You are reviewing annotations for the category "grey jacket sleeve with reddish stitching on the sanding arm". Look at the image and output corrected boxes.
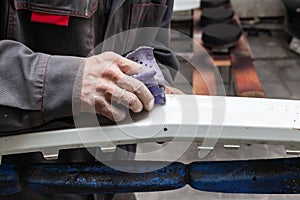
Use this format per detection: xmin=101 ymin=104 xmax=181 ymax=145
xmin=0 ymin=40 xmax=84 ymax=134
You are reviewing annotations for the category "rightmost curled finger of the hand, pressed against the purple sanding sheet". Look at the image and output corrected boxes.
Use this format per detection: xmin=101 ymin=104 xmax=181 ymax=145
xmin=117 ymin=76 xmax=154 ymax=111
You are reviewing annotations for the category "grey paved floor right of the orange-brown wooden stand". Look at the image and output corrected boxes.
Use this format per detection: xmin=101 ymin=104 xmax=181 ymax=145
xmin=248 ymin=32 xmax=300 ymax=99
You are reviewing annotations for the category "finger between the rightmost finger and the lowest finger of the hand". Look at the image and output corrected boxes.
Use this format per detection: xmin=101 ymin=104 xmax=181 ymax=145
xmin=112 ymin=86 xmax=143 ymax=113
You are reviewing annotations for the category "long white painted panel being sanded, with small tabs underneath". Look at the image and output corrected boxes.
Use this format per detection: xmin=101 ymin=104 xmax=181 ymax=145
xmin=0 ymin=95 xmax=300 ymax=162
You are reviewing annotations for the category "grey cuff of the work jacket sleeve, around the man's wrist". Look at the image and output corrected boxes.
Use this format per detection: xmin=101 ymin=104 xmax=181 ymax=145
xmin=41 ymin=56 xmax=85 ymax=123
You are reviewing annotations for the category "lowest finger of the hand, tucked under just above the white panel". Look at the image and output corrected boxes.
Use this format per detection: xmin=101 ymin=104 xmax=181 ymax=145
xmin=95 ymin=96 xmax=126 ymax=122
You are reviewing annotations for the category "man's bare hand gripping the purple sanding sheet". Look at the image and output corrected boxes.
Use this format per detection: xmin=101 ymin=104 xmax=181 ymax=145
xmin=81 ymin=52 xmax=154 ymax=121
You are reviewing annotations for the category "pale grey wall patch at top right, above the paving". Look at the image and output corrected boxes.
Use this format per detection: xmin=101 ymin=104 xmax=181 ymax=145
xmin=231 ymin=0 xmax=284 ymax=18
